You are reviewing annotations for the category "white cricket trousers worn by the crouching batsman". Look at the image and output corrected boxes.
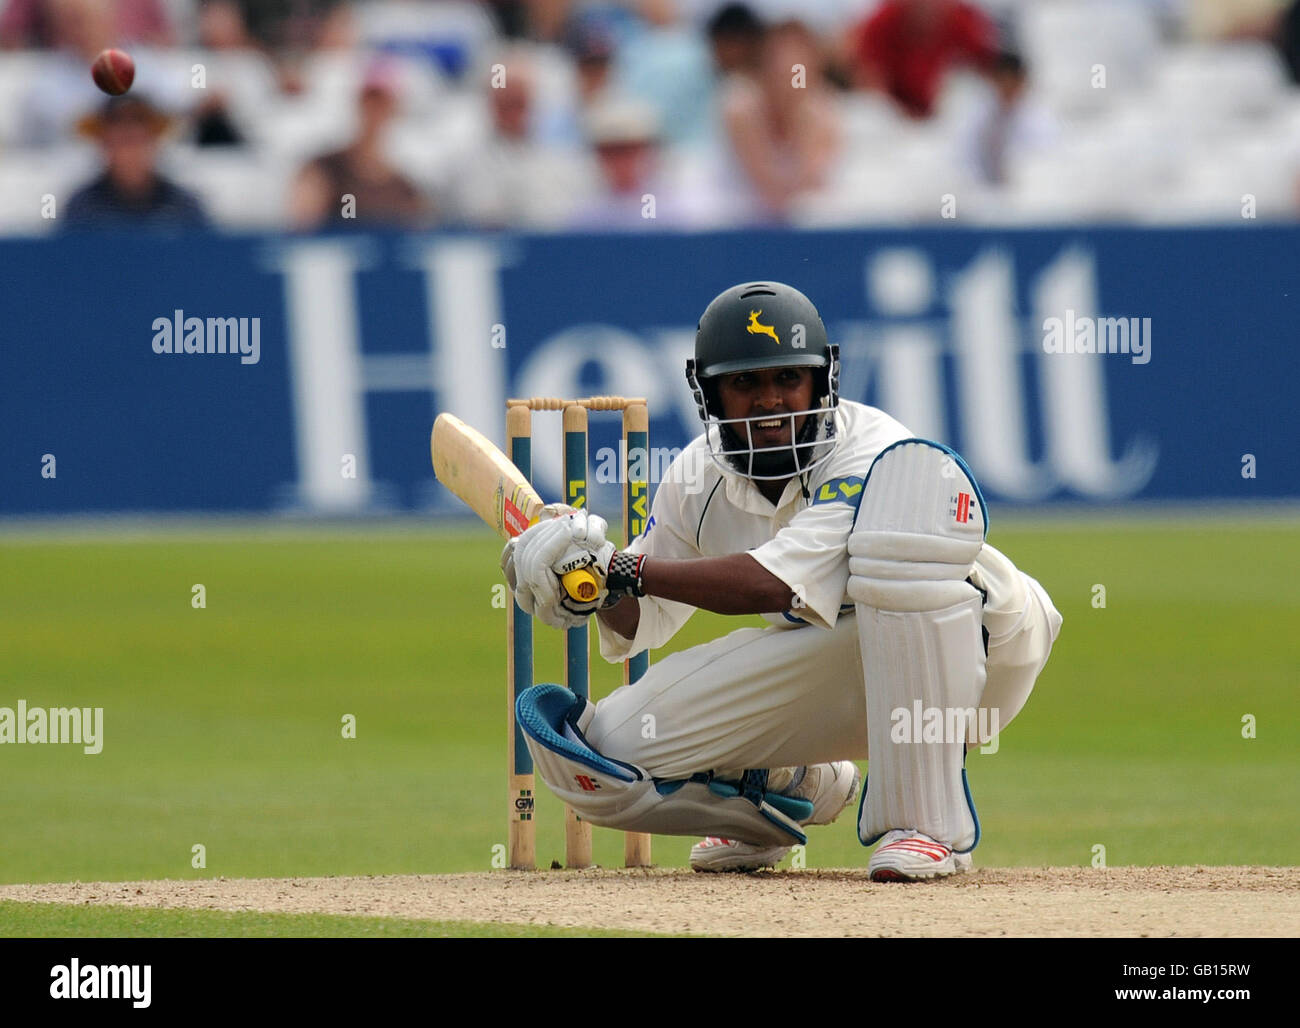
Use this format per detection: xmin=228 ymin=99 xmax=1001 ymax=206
xmin=586 ymin=546 xmax=1061 ymax=778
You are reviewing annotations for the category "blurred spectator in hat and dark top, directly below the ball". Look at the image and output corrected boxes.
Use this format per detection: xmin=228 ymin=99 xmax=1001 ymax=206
xmin=62 ymin=94 xmax=208 ymax=229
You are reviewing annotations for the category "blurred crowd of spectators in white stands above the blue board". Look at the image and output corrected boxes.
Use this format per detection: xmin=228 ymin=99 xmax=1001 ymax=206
xmin=0 ymin=0 xmax=1300 ymax=233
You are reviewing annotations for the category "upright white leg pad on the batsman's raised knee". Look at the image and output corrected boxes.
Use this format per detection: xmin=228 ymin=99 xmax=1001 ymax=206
xmin=848 ymin=439 xmax=985 ymax=851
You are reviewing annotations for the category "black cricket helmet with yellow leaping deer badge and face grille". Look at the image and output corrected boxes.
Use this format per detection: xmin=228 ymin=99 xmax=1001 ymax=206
xmin=686 ymin=282 xmax=840 ymax=481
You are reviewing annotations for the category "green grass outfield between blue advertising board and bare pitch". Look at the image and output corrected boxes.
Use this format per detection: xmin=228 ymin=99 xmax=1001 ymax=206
xmin=0 ymin=519 xmax=1300 ymax=899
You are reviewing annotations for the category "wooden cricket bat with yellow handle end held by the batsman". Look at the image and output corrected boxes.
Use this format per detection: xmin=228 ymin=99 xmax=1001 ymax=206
xmin=429 ymin=413 xmax=601 ymax=603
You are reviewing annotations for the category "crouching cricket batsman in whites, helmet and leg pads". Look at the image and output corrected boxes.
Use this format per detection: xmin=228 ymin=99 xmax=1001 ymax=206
xmin=502 ymin=282 xmax=1061 ymax=881
